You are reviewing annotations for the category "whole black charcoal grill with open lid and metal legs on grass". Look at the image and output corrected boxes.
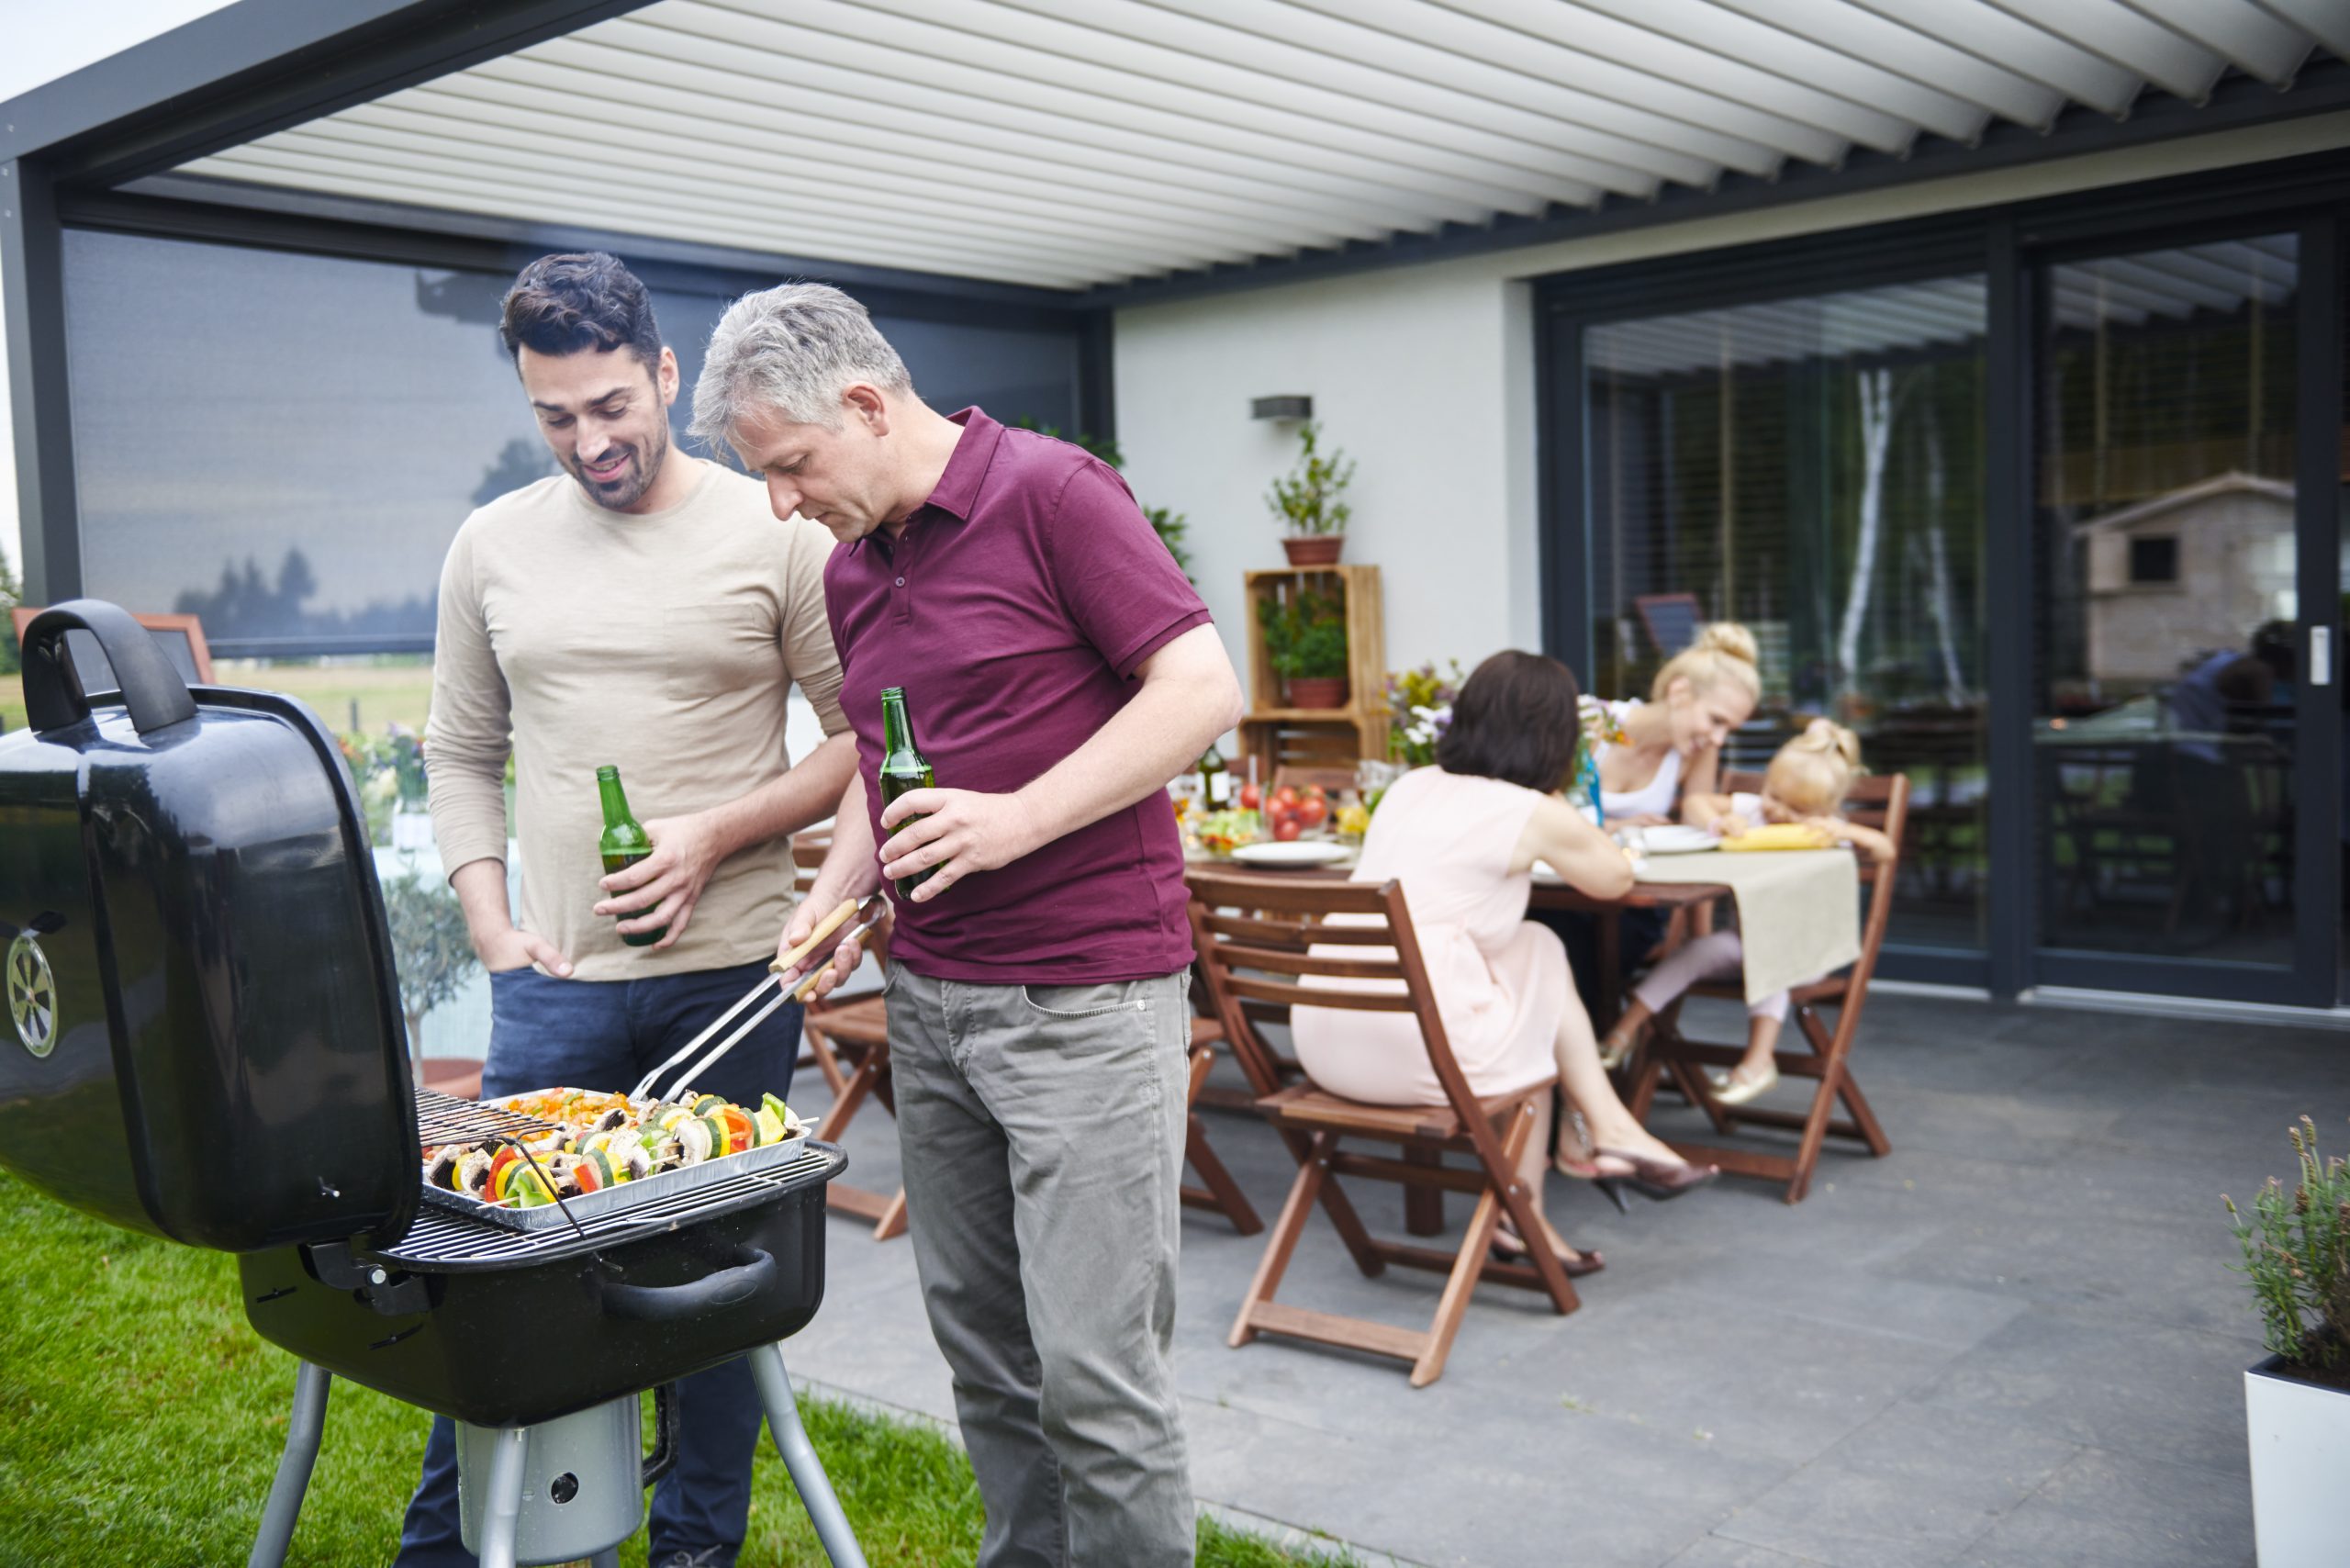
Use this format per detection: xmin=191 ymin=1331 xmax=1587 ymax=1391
xmin=0 ymin=599 xmax=863 ymax=1568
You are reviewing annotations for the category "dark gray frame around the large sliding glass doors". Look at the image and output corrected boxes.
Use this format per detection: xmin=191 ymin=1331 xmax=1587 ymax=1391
xmin=1535 ymin=152 xmax=2350 ymax=1006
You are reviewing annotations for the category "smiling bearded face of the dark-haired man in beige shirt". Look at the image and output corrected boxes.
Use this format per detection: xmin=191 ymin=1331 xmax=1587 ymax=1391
xmin=517 ymin=345 xmax=677 ymax=512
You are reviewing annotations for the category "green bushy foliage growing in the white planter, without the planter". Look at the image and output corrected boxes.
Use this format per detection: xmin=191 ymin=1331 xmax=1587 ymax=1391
xmin=2221 ymin=1116 xmax=2350 ymax=1378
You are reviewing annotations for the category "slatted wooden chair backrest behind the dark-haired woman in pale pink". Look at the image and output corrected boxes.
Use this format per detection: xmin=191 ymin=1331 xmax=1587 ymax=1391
xmin=1187 ymin=869 xmax=1499 ymax=1159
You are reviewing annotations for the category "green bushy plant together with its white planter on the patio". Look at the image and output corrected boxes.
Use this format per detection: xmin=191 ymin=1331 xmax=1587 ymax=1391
xmin=2221 ymin=1116 xmax=2350 ymax=1568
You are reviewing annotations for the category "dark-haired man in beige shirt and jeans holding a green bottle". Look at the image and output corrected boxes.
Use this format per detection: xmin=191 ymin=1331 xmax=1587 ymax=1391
xmin=399 ymin=254 xmax=856 ymax=1568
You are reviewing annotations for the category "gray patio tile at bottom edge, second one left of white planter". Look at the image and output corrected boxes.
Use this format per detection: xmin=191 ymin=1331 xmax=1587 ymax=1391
xmin=1716 ymin=1404 xmax=2080 ymax=1568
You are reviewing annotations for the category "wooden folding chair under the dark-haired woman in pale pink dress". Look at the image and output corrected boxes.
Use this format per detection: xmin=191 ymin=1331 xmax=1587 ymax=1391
xmin=1192 ymin=872 xmax=1579 ymax=1387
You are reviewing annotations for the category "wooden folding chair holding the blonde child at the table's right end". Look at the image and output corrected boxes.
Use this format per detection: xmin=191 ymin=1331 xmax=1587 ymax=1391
xmin=1628 ymin=773 xmax=1910 ymax=1204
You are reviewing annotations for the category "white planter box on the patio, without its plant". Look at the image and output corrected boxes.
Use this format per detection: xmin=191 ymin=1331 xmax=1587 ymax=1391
xmin=2244 ymin=1357 xmax=2350 ymax=1568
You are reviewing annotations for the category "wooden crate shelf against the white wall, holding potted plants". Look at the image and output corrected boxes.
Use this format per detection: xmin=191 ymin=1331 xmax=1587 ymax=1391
xmin=1241 ymin=566 xmax=1389 ymax=778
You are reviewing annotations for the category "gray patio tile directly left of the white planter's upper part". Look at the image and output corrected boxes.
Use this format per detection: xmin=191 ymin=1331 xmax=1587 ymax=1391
xmin=1915 ymin=1307 xmax=2258 ymax=1485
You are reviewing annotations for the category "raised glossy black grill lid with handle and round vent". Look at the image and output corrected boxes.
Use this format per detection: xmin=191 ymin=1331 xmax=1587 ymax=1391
xmin=0 ymin=599 xmax=420 ymax=1250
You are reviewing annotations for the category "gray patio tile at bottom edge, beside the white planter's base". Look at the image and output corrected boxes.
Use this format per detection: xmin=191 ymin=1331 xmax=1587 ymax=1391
xmin=1951 ymin=1448 xmax=2254 ymax=1568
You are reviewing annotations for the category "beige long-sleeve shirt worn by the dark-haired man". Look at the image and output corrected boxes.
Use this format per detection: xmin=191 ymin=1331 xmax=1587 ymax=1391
xmin=425 ymin=456 xmax=846 ymax=980
